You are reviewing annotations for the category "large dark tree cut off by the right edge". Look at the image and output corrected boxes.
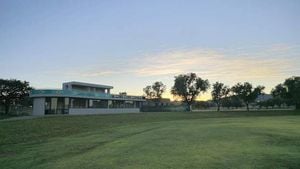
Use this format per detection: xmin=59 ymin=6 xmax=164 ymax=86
xmin=272 ymin=77 xmax=300 ymax=109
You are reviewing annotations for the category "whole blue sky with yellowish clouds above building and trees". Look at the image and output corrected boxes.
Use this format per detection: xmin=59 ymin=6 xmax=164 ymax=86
xmin=0 ymin=0 xmax=300 ymax=100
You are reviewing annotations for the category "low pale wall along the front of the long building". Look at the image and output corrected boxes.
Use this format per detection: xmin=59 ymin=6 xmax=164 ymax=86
xmin=69 ymin=108 xmax=140 ymax=115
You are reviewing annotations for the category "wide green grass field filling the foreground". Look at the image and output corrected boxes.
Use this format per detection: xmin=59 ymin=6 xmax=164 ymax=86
xmin=0 ymin=111 xmax=300 ymax=169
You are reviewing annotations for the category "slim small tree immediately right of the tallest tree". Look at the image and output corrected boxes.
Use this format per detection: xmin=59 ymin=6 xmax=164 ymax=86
xmin=211 ymin=82 xmax=230 ymax=111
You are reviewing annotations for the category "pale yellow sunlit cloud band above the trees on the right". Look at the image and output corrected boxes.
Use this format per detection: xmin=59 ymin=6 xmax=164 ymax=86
xmin=134 ymin=49 xmax=295 ymax=83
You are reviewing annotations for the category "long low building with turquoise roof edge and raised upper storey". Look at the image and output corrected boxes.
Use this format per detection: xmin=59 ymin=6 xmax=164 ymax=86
xmin=30 ymin=81 xmax=145 ymax=115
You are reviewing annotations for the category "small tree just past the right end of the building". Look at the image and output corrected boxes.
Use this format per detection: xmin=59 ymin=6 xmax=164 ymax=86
xmin=143 ymin=82 xmax=166 ymax=99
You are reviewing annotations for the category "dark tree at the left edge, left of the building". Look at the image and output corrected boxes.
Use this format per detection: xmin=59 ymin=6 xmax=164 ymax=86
xmin=0 ymin=79 xmax=32 ymax=114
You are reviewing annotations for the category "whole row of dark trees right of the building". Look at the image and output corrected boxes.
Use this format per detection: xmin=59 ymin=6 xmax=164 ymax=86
xmin=144 ymin=73 xmax=300 ymax=111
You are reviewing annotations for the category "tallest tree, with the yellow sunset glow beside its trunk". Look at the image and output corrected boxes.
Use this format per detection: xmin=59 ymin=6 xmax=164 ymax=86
xmin=171 ymin=73 xmax=209 ymax=111
